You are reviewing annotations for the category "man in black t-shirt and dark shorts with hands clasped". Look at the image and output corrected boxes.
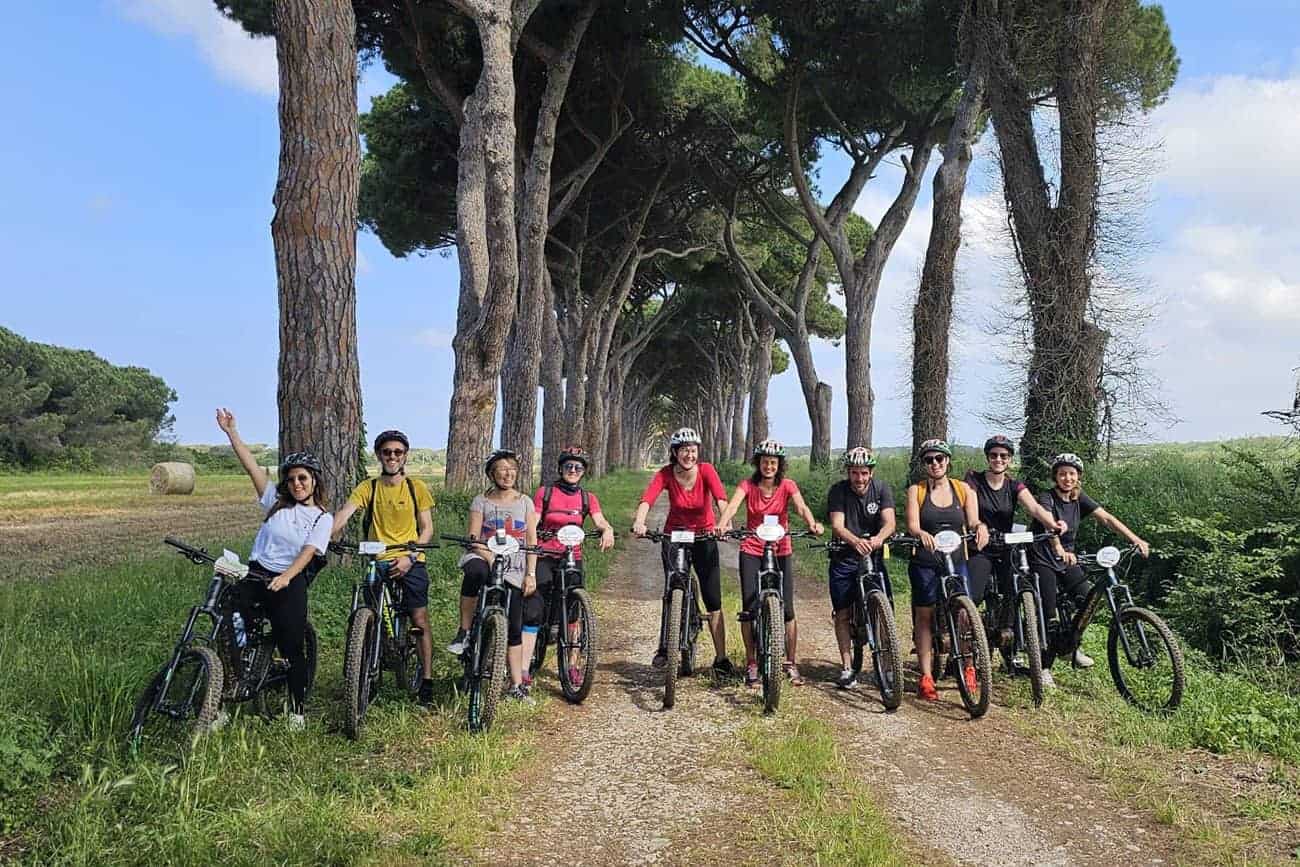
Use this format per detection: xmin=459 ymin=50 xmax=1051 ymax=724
xmin=826 ymin=446 xmax=894 ymax=689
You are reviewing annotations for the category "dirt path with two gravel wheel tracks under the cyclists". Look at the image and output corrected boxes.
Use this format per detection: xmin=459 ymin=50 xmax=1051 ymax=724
xmin=481 ymin=514 xmax=1201 ymax=866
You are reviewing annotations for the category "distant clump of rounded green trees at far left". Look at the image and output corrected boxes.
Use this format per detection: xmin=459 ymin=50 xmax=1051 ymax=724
xmin=0 ymin=328 xmax=176 ymax=469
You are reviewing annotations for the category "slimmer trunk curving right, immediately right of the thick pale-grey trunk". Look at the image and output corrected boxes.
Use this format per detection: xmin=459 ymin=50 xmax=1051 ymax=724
xmin=501 ymin=0 xmax=598 ymax=490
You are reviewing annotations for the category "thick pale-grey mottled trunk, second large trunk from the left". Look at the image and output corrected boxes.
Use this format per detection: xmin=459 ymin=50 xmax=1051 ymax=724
xmin=446 ymin=0 xmax=537 ymax=490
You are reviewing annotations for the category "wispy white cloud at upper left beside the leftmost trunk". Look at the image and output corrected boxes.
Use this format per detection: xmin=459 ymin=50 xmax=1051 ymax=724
xmin=118 ymin=0 xmax=280 ymax=96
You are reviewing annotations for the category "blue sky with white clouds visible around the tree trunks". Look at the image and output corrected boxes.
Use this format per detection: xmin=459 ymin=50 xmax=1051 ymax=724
xmin=0 ymin=6 xmax=1300 ymax=447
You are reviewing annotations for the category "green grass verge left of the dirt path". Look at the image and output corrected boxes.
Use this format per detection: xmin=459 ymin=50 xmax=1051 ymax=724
xmin=0 ymin=474 xmax=642 ymax=864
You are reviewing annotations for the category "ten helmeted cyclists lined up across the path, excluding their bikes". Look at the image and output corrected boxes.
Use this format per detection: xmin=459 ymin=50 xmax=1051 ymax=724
xmin=217 ymin=408 xmax=1149 ymax=728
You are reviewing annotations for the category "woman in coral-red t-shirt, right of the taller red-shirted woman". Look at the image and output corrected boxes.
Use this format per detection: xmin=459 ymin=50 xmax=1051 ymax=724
xmin=719 ymin=439 xmax=822 ymax=686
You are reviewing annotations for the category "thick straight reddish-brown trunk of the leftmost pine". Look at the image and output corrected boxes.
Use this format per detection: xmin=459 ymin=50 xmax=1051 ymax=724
xmin=270 ymin=0 xmax=361 ymax=507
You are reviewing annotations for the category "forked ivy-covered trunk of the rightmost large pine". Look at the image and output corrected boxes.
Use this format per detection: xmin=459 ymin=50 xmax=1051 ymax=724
xmin=972 ymin=0 xmax=1109 ymax=482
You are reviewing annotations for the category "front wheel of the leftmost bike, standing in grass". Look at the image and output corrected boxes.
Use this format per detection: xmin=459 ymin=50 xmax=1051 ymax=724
xmin=127 ymin=647 xmax=224 ymax=750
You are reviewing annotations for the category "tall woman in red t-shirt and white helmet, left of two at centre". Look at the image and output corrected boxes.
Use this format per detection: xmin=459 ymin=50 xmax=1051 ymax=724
xmin=632 ymin=428 xmax=735 ymax=675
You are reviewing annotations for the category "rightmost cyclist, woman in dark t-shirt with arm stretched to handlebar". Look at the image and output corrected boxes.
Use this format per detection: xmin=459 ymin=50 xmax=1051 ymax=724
xmin=1030 ymin=452 xmax=1151 ymax=686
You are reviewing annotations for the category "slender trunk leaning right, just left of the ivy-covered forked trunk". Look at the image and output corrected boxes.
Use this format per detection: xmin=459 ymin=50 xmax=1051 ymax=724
xmin=909 ymin=51 xmax=987 ymax=474
